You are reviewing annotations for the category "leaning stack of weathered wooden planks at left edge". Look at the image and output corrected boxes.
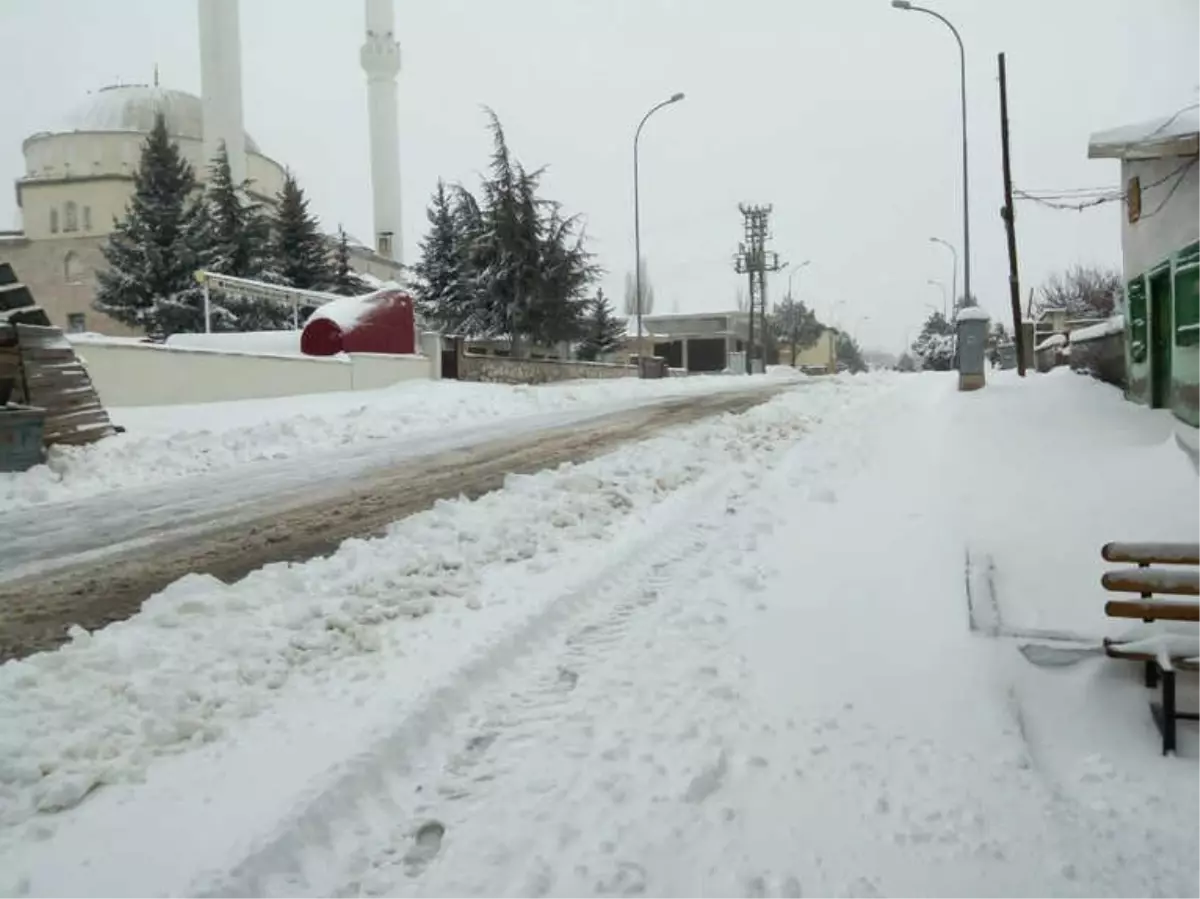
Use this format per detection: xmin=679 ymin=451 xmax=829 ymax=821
xmin=0 ymin=324 xmax=116 ymax=446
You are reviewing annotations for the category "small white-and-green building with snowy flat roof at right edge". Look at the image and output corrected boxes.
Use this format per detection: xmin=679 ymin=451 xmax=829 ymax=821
xmin=1088 ymin=110 xmax=1200 ymax=425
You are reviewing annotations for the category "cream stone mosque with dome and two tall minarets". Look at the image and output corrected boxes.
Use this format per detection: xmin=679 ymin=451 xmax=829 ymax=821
xmin=0 ymin=0 xmax=402 ymax=335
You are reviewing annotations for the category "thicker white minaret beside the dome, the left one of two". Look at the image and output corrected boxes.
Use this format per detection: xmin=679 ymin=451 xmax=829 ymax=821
xmin=199 ymin=0 xmax=246 ymax=184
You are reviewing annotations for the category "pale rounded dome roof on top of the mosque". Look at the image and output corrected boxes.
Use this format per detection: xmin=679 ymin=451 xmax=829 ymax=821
xmin=53 ymin=84 xmax=262 ymax=155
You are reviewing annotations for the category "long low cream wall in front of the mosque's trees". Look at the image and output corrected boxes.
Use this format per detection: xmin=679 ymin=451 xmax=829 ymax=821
xmin=76 ymin=341 xmax=437 ymax=407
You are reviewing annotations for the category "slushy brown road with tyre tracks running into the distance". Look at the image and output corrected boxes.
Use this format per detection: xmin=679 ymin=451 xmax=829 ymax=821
xmin=0 ymin=386 xmax=780 ymax=661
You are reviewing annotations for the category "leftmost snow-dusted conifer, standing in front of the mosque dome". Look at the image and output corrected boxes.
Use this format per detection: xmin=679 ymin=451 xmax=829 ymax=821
xmin=94 ymin=115 xmax=205 ymax=335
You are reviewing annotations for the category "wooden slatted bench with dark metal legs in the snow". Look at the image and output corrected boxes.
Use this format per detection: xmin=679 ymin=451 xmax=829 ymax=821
xmin=1100 ymin=543 xmax=1200 ymax=755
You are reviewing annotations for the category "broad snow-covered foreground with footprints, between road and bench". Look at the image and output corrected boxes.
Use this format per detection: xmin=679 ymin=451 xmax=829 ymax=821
xmin=0 ymin=373 xmax=1200 ymax=899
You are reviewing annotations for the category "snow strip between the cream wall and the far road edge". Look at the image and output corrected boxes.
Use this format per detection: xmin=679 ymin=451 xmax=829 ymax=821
xmin=0 ymin=373 xmax=800 ymax=509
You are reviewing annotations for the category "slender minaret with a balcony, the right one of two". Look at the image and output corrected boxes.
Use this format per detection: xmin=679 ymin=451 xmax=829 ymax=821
xmin=362 ymin=0 xmax=404 ymax=263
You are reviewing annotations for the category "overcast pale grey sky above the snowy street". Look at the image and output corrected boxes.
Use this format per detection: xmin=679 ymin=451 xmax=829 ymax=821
xmin=0 ymin=0 xmax=1200 ymax=349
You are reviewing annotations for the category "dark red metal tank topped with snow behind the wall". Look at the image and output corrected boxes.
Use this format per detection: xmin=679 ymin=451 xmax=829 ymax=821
xmin=300 ymin=289 xmax=416 ymax=355
